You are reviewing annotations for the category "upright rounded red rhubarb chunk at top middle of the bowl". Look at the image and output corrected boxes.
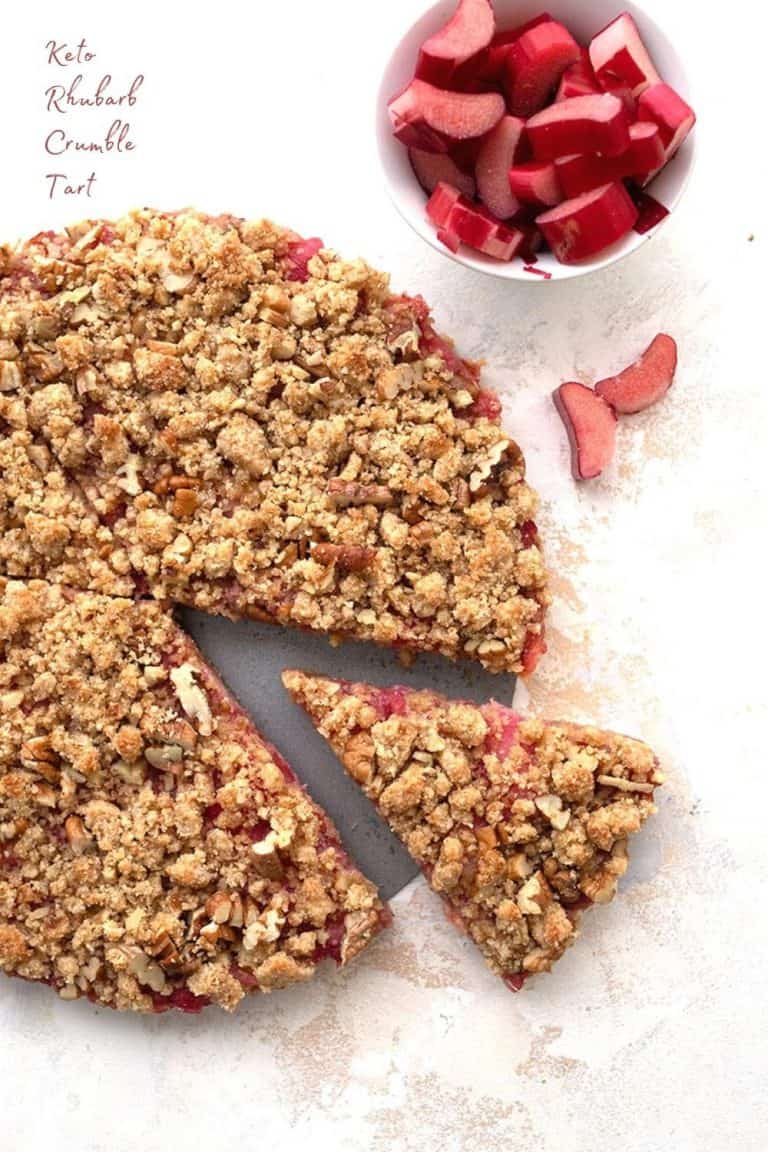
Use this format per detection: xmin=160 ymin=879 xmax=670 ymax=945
xmin=504 ymin=20 xmax=580 ymax=116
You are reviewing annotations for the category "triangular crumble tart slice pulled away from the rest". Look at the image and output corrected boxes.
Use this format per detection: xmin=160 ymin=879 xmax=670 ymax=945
xmin=283 ymin=672 xmax=663 ymax=990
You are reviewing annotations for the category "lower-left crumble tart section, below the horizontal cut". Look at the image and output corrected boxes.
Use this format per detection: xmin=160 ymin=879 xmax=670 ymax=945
xmin=0 ymin=579 xmax=388 ymax=1011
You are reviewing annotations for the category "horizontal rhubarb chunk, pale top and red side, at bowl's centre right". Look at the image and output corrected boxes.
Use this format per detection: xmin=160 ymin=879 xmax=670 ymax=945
xmin=525 ymin=92 xmax=630 ymax=160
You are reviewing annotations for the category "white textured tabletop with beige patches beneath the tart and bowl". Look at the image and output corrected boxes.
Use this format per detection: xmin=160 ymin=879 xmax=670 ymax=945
xmin=0 ymin=0 xmax=768 ymax=1152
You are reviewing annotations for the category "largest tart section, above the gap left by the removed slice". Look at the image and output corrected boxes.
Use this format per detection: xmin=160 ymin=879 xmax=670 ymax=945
xmin=0 ymin=211 xmax=547 ymax=673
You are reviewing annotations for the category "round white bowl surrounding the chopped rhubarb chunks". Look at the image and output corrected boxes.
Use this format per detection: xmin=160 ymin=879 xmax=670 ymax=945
xmin=377 ymin=0 xmax=695 ymax=283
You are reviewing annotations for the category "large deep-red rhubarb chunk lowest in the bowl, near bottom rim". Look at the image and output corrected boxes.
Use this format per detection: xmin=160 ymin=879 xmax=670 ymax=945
xmin=537 ymin=182 xmax=638 ymax=264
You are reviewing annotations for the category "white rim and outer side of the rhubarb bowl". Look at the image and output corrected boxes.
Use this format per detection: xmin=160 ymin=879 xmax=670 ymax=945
xmin=374 ymin=0 xmax=697 ymax=285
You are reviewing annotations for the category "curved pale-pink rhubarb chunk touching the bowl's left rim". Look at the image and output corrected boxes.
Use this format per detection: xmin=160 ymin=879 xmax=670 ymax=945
xmin=388 ymin=79 xmax=504 ymax=152
